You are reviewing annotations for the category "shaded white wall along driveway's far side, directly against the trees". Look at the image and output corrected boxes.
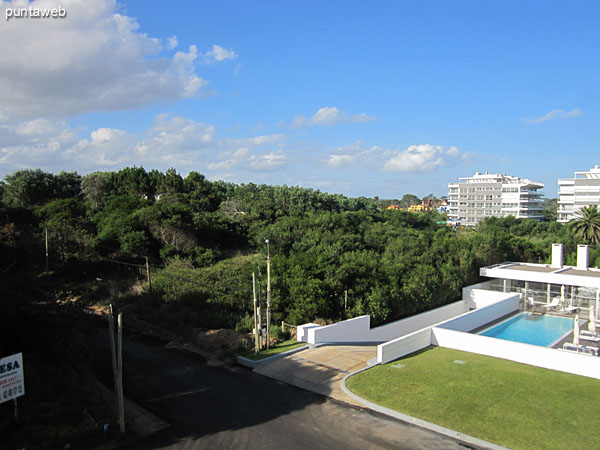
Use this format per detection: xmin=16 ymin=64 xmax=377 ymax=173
xmin=308 ymin=300 xmax=469 ymax=344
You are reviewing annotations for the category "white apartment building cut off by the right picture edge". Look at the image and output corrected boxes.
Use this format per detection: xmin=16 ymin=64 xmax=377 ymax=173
xmin=558 ymin=165 xmax=600 ymax=222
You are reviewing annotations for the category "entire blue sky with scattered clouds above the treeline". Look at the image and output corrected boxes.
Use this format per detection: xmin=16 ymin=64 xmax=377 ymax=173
xmin=0 ymin=0 xmax=600 ymax=198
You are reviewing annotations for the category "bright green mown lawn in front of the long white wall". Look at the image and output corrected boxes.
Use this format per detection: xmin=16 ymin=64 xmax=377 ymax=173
xmin=347 ymin=347 xmax=600 ymax=449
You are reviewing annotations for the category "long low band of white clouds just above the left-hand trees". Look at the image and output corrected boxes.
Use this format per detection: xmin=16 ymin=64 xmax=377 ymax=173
xmin=0 ymin=114 xmax=287 ymax=173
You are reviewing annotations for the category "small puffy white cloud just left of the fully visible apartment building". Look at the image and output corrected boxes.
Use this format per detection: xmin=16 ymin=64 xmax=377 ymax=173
xmin=382 ymin=144 xmax=465 ymax=172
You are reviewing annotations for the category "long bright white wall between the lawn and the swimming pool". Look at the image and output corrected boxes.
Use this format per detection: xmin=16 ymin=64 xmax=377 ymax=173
xmin=432 ymin=327 xmax=600 ymax=379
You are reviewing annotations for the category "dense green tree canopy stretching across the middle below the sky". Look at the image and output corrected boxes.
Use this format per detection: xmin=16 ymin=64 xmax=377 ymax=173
xmin=0 ymin=167 xmax=600 ymax=329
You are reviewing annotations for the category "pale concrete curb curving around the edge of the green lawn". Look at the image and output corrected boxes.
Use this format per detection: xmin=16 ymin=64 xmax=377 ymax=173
xmin=342 ymin=366 xmax=509 ymax=450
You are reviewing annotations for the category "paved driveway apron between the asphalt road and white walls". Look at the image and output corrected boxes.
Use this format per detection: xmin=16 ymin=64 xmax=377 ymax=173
xmin=254 ymin=345 xmax=377 ymax=406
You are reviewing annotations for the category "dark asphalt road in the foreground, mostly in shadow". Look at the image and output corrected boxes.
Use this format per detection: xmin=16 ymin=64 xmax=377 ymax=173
xmin=93 ymin=331 xmax=474 ymax=450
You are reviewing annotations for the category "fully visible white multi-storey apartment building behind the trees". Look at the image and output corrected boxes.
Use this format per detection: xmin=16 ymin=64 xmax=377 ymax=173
xmin=448 ymin=172 xmax=544 ymax=226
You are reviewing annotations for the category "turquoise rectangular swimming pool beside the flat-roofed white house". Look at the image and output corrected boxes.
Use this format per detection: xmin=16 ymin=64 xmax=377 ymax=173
xmin=479 ymin=313 xmax=573 ymax=347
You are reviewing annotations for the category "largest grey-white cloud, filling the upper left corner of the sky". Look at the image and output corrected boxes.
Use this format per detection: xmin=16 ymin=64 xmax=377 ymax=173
xmin=0 ymin=0 xmax=209 ymax=120
